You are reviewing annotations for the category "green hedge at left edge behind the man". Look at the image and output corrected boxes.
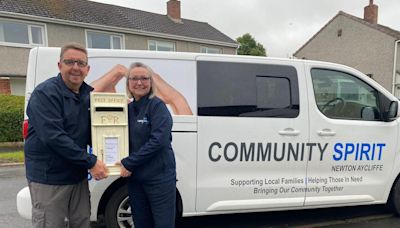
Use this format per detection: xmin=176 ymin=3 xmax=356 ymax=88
xmin=0 ymin=95 xmax=25 ymax=142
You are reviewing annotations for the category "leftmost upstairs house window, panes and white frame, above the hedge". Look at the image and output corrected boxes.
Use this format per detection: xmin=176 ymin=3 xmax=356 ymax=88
xmin=0 ymin=20 xmax=45 ymax=46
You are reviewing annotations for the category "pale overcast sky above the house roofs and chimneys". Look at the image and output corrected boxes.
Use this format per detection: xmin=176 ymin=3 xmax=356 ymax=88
xmin=90 ymin=0 xmax=400 ymax=57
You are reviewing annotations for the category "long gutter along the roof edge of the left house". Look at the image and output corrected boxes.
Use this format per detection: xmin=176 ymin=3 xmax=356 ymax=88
xmin=0 ymin=11 xmax=239 ymax=48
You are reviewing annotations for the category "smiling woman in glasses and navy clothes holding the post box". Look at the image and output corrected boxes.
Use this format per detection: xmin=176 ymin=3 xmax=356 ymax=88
xmin=121 ymin=63 xmax=176 ymax=228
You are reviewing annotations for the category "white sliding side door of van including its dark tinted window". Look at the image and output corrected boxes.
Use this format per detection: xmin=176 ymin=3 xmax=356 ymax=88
xmin=196 ymin=57 xmax=308 ymax=214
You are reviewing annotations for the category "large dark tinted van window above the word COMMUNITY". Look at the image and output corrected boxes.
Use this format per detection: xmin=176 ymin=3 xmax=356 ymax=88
xmin=197 ymin=61 xmax=299 ymax=118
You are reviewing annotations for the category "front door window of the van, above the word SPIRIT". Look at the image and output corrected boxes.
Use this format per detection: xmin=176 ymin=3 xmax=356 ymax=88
xmin=311 ymin=69 xmax=381 ymax=120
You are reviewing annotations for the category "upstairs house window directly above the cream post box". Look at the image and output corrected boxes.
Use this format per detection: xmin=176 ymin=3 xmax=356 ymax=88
xmin=86 ymin=31 xmax=123 ymax=49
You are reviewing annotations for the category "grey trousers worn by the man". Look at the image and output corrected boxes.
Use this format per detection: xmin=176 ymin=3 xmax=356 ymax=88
xmin=28 ymin=179 xmax=90 ymax=228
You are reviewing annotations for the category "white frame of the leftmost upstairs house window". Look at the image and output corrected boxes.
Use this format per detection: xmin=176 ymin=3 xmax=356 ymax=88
xmin=0 ymin=18 xmax=48 ymax=48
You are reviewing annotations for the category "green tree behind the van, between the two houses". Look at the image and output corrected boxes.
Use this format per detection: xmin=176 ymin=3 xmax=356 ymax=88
xmin=236 ymin=33 xmax=267 ymax=56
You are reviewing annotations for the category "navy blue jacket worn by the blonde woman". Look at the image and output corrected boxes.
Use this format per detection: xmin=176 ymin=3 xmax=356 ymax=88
xmin=121 ymin=96 xmax=176 ymax=183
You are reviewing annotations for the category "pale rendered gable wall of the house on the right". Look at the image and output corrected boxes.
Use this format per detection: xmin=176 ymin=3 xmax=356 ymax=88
xmin=294 ymin=11 xmax=400 ymax=94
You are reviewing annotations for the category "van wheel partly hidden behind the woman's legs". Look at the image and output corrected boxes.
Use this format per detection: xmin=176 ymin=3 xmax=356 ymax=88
xmin=105 ymin=185 xmax=134 ymax=228
